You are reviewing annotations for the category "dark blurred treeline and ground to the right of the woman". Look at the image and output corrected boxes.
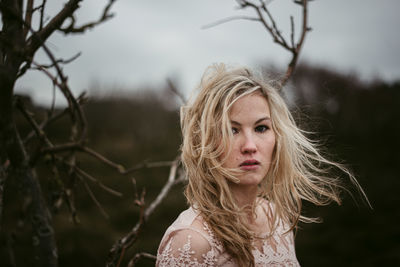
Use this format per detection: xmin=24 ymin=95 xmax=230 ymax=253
xmin=292 ymin=66 xmax=400 ymax=266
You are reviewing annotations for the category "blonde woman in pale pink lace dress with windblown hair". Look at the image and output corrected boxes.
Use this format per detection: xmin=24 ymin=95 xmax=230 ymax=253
xmin=157 ymin=64 xmax=366 ymax=266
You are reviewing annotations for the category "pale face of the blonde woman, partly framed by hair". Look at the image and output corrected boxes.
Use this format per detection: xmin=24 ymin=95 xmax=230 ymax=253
xmin=223 ymin=92 xmax=275 ymax=185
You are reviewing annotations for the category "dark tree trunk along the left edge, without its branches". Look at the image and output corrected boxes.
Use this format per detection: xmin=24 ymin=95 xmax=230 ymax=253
xmin=0 ymin=0 xmax=57 ymax=266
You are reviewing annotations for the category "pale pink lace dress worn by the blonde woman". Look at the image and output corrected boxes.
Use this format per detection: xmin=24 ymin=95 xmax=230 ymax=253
xmin=156 ymin=204 xmax=300 ymax=267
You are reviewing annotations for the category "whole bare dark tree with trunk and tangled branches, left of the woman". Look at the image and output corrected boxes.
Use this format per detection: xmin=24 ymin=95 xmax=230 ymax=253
xmin=0 ymin=0 xmax=155 ymax=266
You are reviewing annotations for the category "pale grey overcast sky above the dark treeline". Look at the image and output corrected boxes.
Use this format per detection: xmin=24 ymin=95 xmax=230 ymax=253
xmin=17 ymin=0 xmax=400 ymax=103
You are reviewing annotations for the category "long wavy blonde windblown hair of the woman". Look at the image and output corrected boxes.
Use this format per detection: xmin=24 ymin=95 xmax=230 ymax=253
xmin=181 ymin=64 xmax=368 ymax=266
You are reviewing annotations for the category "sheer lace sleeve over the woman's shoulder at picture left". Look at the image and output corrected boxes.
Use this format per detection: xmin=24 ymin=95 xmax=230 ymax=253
xmin=156 ymin=229 xmax=216 ymax=267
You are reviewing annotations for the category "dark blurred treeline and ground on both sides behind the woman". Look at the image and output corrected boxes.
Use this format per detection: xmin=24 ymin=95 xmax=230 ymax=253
xmin=0 ymin=65 xmax=400 ymax=266
